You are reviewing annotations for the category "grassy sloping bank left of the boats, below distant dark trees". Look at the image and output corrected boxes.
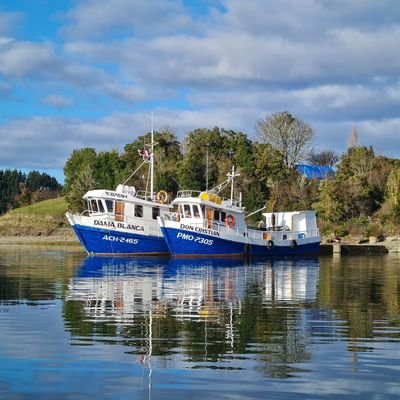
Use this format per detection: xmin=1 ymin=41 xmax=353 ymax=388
xmin=0 ymin=197 xmax=75 ymax=240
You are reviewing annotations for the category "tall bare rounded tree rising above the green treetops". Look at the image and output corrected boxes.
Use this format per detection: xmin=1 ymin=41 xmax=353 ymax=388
xmin=256 ymin=111 xmax=314 ymax=168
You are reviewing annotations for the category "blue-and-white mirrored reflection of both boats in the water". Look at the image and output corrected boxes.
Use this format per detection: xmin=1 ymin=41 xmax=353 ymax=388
xmin=67 ymin=257 xmax=319 ymax=321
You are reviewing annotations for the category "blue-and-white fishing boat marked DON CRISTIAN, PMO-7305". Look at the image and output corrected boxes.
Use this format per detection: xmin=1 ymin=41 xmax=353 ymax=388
xmin=158 ymin=167 xmax=320 ymax=257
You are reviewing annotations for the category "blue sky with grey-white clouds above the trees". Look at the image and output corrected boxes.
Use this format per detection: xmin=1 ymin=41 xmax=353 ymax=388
xmin=0 ymin=0 xmax=400 ymax=181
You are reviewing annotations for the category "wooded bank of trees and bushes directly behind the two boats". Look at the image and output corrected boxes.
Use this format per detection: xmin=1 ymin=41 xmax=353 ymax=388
xmin=64 ymin=112 xmax=400 ymax=236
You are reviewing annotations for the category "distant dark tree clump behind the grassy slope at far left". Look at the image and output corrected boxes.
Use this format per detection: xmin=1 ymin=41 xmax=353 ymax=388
xmin=0 ymin=169 xmax=62 ymax=215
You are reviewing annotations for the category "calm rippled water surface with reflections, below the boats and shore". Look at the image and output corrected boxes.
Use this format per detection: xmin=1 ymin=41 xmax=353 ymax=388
xmin=0 ymin=245 xmax=400 ymax=400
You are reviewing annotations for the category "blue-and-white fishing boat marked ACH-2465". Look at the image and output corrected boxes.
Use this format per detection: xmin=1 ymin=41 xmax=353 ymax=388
xmin=66 ymin=130 xmax=172 ymax=256
